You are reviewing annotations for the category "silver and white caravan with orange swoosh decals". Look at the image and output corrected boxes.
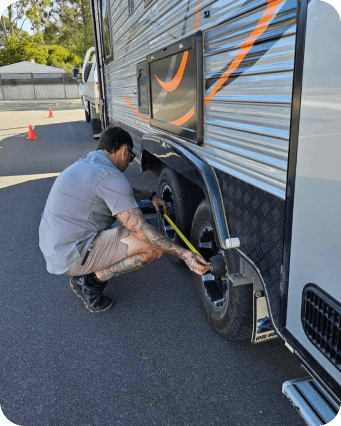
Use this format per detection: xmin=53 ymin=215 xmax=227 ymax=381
xmin=90 ymin=0 xmax=341 ymax=426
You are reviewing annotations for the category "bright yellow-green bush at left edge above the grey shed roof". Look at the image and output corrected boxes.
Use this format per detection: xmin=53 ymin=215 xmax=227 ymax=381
xmin=0 ymin=34 xmax=48 ymax=66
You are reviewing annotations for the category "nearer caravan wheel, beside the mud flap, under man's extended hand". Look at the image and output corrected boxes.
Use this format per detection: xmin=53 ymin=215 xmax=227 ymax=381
xmin=191 ymin=200 xmax=253 ymax=340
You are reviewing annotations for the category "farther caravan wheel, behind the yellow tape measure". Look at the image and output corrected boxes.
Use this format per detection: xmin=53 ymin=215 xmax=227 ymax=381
xmin=157 ymin=167 xmax=197 ymax=264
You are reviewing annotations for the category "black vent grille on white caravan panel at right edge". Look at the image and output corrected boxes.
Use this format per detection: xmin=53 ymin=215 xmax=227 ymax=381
xmin=302 ymin=285 xmax=341 ymax=371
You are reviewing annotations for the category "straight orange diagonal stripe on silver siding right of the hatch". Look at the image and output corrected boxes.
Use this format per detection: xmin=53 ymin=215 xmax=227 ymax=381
xmin=205 ymin=0 xmax=282 ymax=105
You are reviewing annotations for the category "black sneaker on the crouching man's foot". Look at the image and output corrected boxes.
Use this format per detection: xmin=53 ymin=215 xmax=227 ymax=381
xmin=70 ymin=275 xmax=114 ymax=313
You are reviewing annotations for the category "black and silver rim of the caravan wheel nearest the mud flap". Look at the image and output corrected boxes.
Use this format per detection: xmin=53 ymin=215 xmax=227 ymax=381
xmin=199 ymin=226 xmax=229 ymax=311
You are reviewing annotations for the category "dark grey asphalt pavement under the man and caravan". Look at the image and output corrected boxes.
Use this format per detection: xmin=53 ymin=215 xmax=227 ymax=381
xmin=0 ymin=107 xmax=306 ymax=426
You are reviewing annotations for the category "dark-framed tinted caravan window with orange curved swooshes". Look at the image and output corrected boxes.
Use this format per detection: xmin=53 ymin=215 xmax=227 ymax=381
xmin=147 ymin=32 xmax=204 ymax=143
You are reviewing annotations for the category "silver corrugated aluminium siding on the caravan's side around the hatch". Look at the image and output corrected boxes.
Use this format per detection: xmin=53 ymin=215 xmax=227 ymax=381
xmin=101 ymin=0 xmax=296 ymax=199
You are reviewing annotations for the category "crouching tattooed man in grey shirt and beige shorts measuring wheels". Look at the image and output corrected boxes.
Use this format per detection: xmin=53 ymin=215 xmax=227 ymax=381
xmin=39 ymin=127 xmax=211 ymax=313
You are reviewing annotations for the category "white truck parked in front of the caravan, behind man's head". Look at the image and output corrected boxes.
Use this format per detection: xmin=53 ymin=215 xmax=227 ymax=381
xmin=80 ymin=47 xmax=102 ymax=138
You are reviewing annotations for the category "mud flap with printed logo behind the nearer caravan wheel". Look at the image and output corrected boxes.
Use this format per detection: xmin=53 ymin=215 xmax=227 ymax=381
xmin=251 ymin=291 xmax=277 ymax=343
